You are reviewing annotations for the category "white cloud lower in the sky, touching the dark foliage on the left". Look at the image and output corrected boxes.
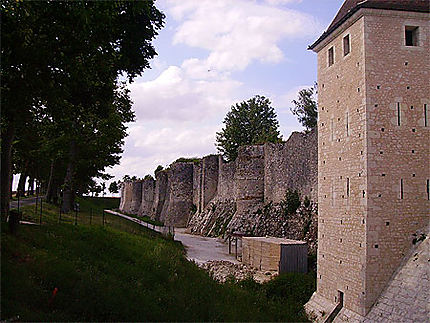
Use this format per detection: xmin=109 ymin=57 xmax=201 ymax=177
xmin=130 ymin=66 xmax=241 ymax=122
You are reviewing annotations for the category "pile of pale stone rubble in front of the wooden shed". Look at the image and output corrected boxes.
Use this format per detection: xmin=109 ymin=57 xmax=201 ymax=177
xmin=200 ymin=260 xmax=278 ymax=283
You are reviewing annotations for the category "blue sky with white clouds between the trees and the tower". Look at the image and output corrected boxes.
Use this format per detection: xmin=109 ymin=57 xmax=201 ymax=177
xmin=107 ymin=0 xmax=342 ymax=185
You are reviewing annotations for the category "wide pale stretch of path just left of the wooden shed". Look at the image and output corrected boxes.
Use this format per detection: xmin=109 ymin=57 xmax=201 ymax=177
xmin=175 ymin=229 xmax=239 ymax=264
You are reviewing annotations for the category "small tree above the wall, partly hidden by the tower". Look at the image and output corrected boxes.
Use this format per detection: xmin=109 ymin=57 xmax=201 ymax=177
xmin=291 ymin=84 xmax=318 ymax=130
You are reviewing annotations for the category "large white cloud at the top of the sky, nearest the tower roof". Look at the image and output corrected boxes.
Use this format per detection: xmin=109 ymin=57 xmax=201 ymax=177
xmin=168 ymin=0 xmax=321 ymax=72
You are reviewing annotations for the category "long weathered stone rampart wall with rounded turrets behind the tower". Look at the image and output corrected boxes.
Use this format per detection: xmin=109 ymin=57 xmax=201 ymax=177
xmin=121 ymin=131 xmax=317 ymax=233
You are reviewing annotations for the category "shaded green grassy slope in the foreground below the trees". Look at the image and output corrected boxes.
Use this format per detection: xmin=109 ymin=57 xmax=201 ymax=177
xmin=1 ymin=200 xmax=315 ymax=321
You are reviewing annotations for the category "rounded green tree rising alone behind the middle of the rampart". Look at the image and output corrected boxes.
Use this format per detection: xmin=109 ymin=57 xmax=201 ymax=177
xmin=216 ymin=95 xmax=282 ymax=161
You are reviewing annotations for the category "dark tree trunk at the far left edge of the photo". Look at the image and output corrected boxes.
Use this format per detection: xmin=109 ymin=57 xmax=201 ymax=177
xmin=0 ymin=124 xmax=15 ymax=219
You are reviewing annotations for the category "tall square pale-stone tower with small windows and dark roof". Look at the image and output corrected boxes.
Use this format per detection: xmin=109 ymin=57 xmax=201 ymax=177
xmin=306 ymin=0 xmax=430 ymax=317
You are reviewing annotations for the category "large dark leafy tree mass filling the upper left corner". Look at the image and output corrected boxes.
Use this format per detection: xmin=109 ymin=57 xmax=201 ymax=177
xmin=1 ymin=0 xmax=164 ymax=216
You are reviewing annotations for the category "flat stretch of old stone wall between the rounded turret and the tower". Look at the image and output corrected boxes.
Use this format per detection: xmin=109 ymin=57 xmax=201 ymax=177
xmin=264 ymin=130 xmax=318 ymax=204
